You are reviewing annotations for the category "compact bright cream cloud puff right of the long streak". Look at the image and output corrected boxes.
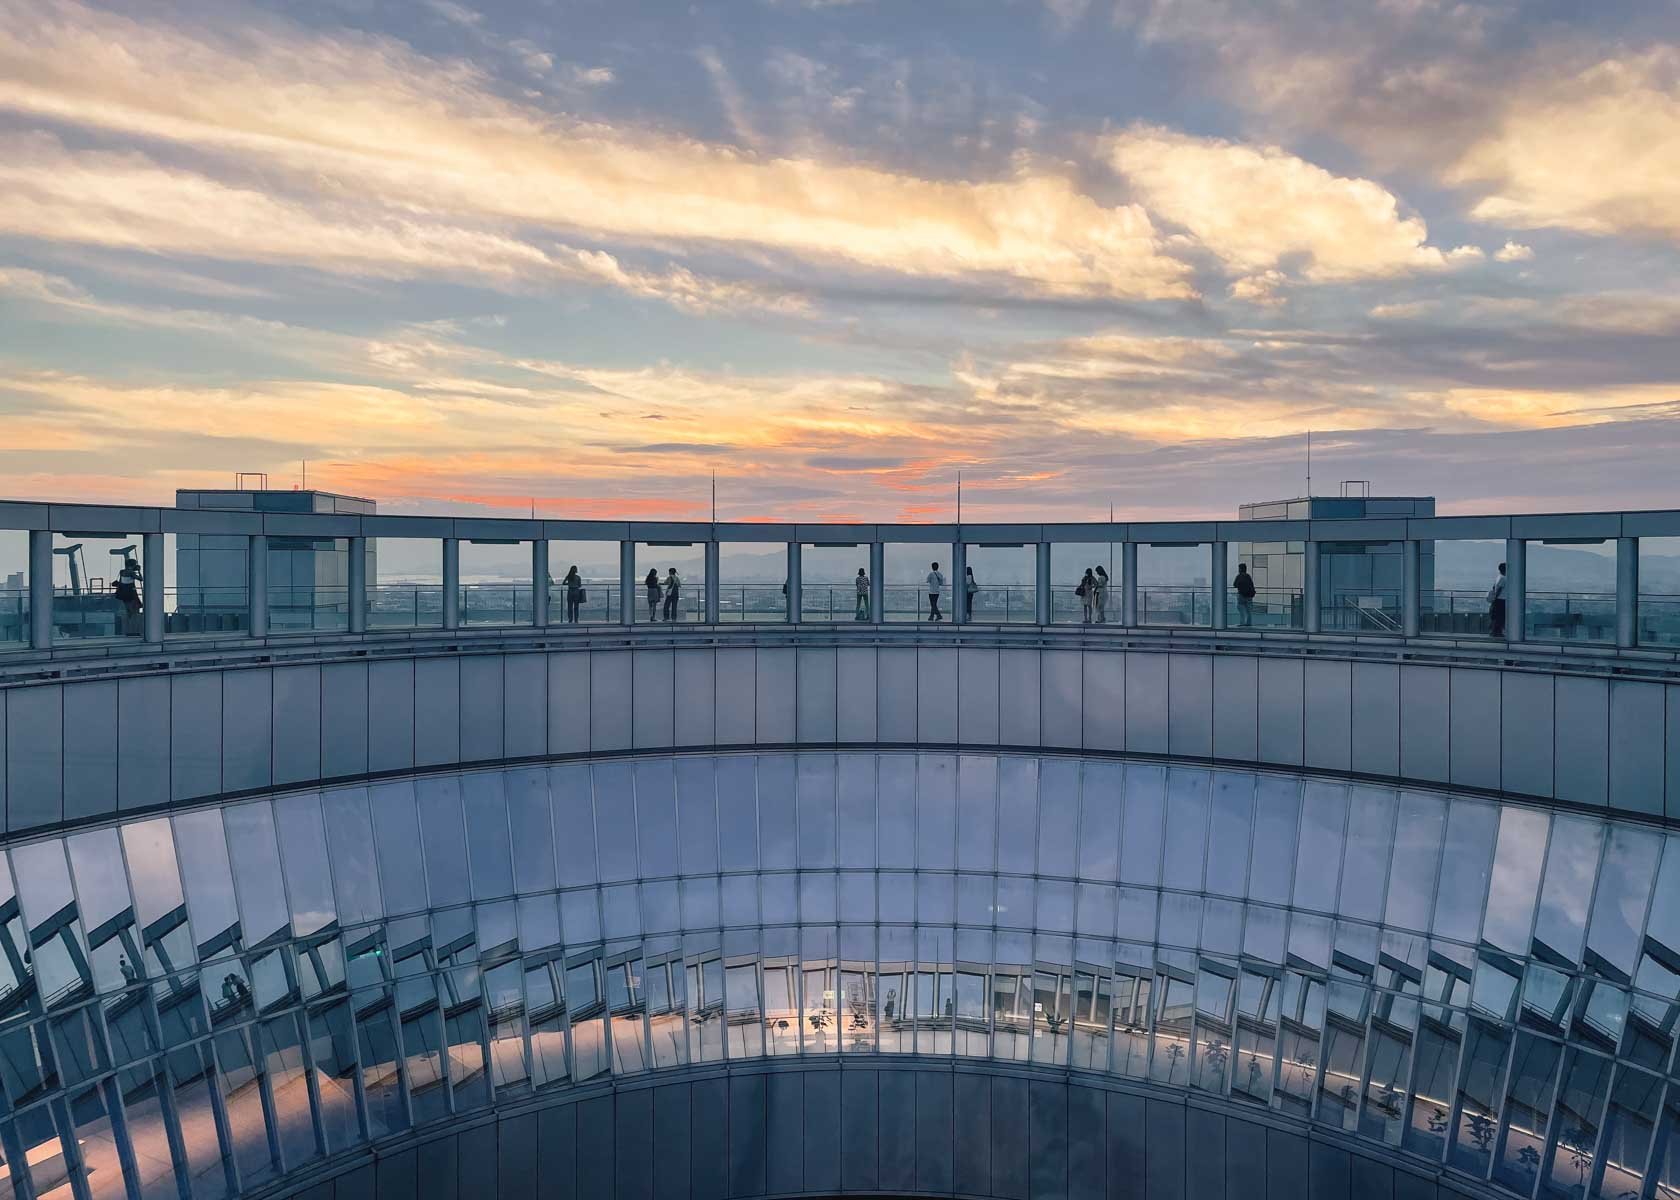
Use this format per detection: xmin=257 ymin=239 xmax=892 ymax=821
xmin=1105 ymin=126 xmax=1480 ymax=285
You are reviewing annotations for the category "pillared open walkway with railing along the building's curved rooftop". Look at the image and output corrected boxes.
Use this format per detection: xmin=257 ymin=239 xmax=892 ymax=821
xmin=0 ymin=503 xmax=1680 ymax=652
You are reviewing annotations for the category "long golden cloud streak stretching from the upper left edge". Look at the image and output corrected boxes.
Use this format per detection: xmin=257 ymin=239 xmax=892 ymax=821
xmin=0 ymin=0 xmax=1193 ymax=299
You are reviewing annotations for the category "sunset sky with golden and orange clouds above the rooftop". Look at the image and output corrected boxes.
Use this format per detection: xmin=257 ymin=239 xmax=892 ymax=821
xmin=0 ymin=0 xmax=1680 ymax=521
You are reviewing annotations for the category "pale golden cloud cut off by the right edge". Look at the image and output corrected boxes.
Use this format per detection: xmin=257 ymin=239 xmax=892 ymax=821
xmin=1446 ymin=47 xmax=1680 ymax=240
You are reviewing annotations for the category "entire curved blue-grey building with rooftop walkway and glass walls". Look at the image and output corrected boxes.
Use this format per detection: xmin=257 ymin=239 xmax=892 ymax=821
xmin=0 ymin=503 xmax=1680 ymax=1200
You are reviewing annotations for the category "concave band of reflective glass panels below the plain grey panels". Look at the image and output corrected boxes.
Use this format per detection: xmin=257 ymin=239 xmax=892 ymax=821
xmin=0 ymin=751 xmax=1680 ymax=1200
